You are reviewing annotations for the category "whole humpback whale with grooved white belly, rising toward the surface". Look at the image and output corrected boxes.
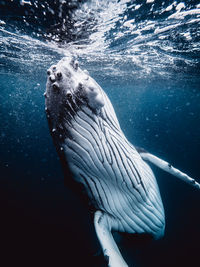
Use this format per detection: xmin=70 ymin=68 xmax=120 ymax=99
xmin=44 ymin=57 xmax=200 ymax=267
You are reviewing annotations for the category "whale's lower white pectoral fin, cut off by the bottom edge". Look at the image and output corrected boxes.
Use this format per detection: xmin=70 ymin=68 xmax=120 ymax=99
xmin=94 ymin=211 xmax=128 ymax=267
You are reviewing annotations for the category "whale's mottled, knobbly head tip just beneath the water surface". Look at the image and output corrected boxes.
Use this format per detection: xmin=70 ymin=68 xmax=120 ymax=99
xmin=44 ymin=57 xmax=104 ymax=137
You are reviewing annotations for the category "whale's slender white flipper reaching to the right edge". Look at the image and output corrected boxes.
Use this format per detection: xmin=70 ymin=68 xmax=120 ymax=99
xmin=140 ymin=152 xmax=200 ymax=189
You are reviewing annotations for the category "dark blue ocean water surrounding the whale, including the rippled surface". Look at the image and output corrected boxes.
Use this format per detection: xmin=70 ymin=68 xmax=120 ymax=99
xmin=0 ymin=0 xmax=200 ymax=267
